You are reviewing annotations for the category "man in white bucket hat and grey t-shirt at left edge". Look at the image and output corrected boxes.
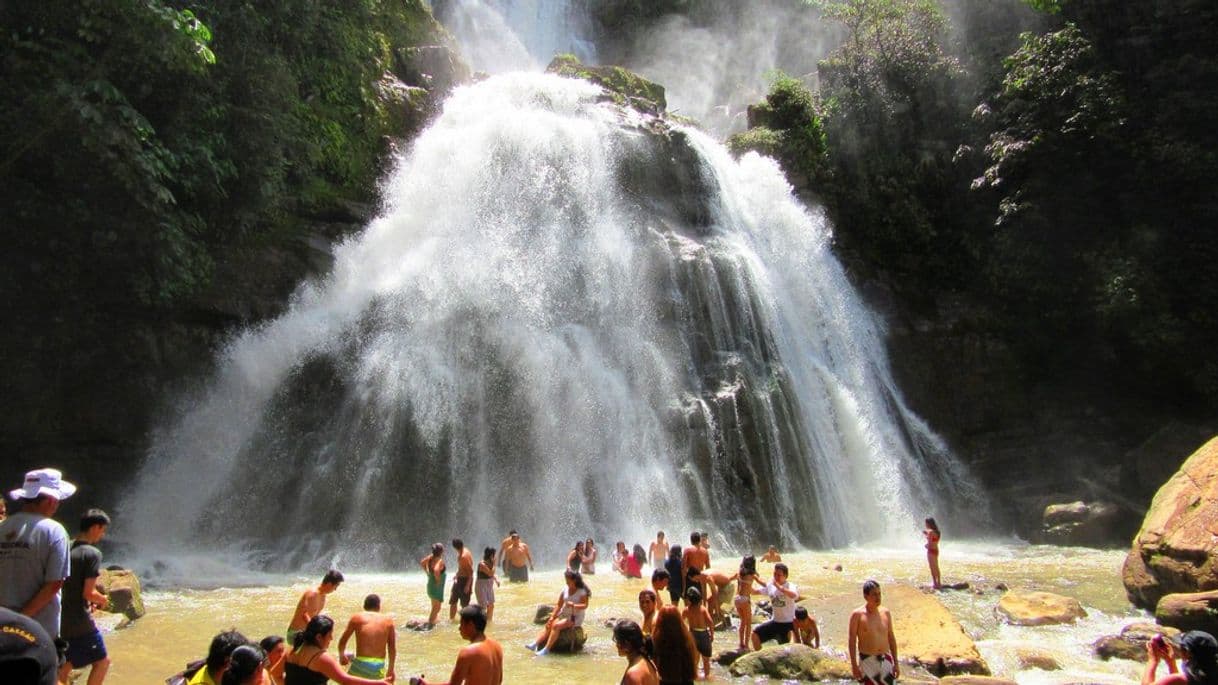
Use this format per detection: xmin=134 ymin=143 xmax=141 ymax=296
xmin=0 ymin=468 xmax=76 ymax=637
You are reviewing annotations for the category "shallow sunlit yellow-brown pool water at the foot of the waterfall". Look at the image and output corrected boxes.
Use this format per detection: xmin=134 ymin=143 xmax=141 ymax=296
xmin=106 ymin=540 xmax=1146 ymax=685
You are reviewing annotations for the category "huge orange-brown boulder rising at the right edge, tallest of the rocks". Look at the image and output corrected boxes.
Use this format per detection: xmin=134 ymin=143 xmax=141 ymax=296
xmin=1122 ymin=438 xmax=1218 ymax=609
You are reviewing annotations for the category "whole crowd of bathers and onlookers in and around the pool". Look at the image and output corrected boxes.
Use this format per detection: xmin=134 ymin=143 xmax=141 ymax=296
xmin=7 ymin=468 xmax=1218 ymax=685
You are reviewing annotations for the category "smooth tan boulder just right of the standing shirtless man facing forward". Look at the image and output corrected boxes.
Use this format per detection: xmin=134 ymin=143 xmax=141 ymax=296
xmin=884 ymin=585 xmax=990 ymax=676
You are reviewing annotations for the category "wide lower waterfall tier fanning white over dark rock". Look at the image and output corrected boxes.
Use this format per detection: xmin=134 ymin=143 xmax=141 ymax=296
xmin=123 ymin=74 xmax=983 ymax=568
